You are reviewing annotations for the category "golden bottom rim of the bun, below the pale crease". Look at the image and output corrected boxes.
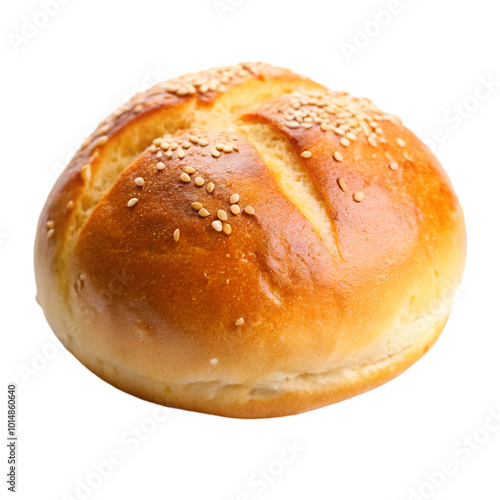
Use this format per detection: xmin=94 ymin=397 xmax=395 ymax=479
xmin=53 ymin=307 xmax=451 ymax=418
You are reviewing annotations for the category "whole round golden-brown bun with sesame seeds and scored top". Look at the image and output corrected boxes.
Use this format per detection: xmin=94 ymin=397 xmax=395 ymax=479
xmin=35 ymin=63 xmax=466 ymax=418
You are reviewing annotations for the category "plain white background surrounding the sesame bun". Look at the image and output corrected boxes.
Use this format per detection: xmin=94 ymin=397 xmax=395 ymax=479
xmin=0 ymin=0 xmax=500 ymax=500
